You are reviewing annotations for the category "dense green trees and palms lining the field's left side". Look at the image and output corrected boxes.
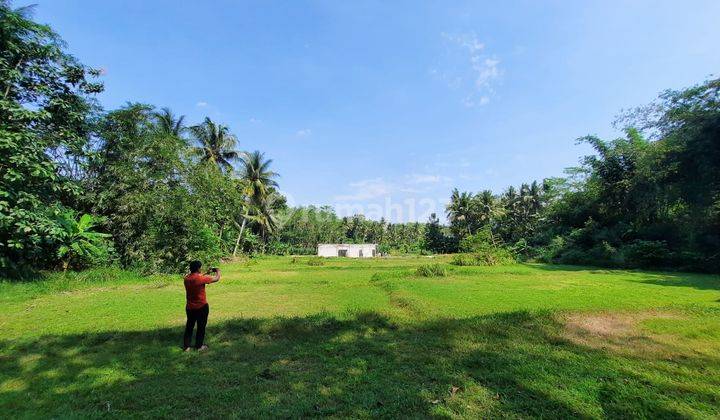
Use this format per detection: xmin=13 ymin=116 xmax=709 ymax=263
xmin=0 ymin=1 xmax=285 ymax=273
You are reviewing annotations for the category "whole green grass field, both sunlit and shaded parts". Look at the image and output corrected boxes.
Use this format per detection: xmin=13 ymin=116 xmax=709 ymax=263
xmin=0 ymin=257 xmax=720 ymax=418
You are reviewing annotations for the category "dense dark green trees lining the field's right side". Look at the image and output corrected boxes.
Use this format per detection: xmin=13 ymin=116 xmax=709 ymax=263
xmin=431 ymin=79 xmax=720 ymax=272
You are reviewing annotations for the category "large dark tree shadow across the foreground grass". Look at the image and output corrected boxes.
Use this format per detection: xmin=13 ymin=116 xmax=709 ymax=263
xmin=0 ymin=312 xmax=720 ymax=418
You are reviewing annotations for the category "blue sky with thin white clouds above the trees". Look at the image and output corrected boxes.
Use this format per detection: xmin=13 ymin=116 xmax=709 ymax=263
xmin=35 ymin=0 xmax=720 ymax=221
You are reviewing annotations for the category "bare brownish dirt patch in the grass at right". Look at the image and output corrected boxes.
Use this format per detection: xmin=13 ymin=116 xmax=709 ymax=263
xmin=562 ymin=311 xmax=682 ymax=356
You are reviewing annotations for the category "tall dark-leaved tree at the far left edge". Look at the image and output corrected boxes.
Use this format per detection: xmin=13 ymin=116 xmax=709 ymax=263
xmin=0 ymin=0 xmax=102 ymax=271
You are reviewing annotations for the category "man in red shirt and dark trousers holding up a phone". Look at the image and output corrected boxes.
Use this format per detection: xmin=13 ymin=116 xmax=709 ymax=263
xmin=183 ymin=261 xmax=220 ymax=351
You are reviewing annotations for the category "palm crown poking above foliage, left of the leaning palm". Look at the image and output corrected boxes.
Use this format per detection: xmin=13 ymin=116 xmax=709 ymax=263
xmin=188 ymin=117 xmax=239 ymax=171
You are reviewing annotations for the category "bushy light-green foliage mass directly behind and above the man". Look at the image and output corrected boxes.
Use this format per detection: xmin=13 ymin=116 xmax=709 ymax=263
xmin=85 ymin=104 xmax=231 ymax=272
